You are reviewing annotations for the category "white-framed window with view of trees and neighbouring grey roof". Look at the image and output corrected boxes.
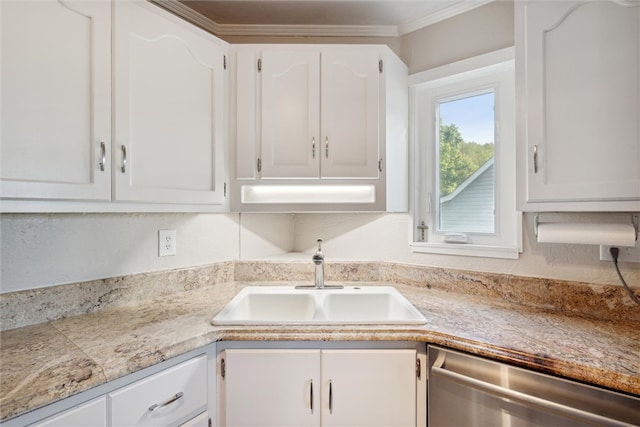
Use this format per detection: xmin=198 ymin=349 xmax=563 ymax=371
xmin=410 ymin=49 xmax=521 ymax=258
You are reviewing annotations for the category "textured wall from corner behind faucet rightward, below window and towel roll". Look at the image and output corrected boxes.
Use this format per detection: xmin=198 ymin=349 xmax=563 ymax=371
xmin=286 ymin=213 xmax=640 ymax=288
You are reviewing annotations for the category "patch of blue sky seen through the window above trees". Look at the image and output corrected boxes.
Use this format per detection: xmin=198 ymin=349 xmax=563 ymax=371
xmin=440 ymin=92 xmax=494 ymax=144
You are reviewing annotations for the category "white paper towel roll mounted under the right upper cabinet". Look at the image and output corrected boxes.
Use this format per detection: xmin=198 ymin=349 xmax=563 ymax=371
xmin=538 ymin=223 xmax=636 ymax=247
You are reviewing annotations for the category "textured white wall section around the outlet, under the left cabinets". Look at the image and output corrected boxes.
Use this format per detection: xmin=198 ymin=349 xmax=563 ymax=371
xmin=0 ymin=214 xmax=239 ymax=293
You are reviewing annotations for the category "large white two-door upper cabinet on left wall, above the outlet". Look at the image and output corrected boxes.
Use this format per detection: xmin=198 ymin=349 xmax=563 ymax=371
xmin=0 ymin=0 xmax=228 ymax=212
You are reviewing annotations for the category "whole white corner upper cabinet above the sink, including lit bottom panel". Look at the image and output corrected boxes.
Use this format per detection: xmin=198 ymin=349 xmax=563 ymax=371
xmin=231 ymin=45 xmax=408 ymax=211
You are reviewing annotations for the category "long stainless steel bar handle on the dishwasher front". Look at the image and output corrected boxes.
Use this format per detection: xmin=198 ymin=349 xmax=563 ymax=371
xmin=431 ymin=353 xmax=633 ymax=427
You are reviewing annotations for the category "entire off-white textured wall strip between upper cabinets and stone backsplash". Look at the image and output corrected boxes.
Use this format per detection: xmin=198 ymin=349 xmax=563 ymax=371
xmin=0 ymin=213 xmax=640 ymax=293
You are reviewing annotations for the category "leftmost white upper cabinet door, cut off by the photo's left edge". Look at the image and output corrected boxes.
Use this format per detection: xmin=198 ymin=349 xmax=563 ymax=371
xmin=0 ymin=0 xmax=111 ymax=200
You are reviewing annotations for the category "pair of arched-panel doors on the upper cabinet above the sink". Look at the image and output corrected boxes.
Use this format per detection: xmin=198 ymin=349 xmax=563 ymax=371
xmin=260 ymin=46 xmax=380 ymax=179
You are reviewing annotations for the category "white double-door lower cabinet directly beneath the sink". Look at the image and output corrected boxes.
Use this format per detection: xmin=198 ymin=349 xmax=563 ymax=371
xmin=218 ymin=349 xmax=423 ymax=427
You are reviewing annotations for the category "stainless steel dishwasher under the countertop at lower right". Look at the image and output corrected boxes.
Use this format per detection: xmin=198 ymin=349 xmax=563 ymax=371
xmin=428 ymin=346 xmax=640 ymax=427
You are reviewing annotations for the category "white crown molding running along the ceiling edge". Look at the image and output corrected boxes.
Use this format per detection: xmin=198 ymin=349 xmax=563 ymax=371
xmin=149 ymin=0 xmax=496 ymax=37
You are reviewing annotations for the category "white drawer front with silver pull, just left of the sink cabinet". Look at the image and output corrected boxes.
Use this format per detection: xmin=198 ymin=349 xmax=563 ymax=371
xmin=108 ymin=355 xmax=207 ymax=427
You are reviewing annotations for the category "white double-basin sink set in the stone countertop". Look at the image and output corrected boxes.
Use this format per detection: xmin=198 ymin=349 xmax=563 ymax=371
xmin=211 ymin=286 xmax=427 ymax=325
